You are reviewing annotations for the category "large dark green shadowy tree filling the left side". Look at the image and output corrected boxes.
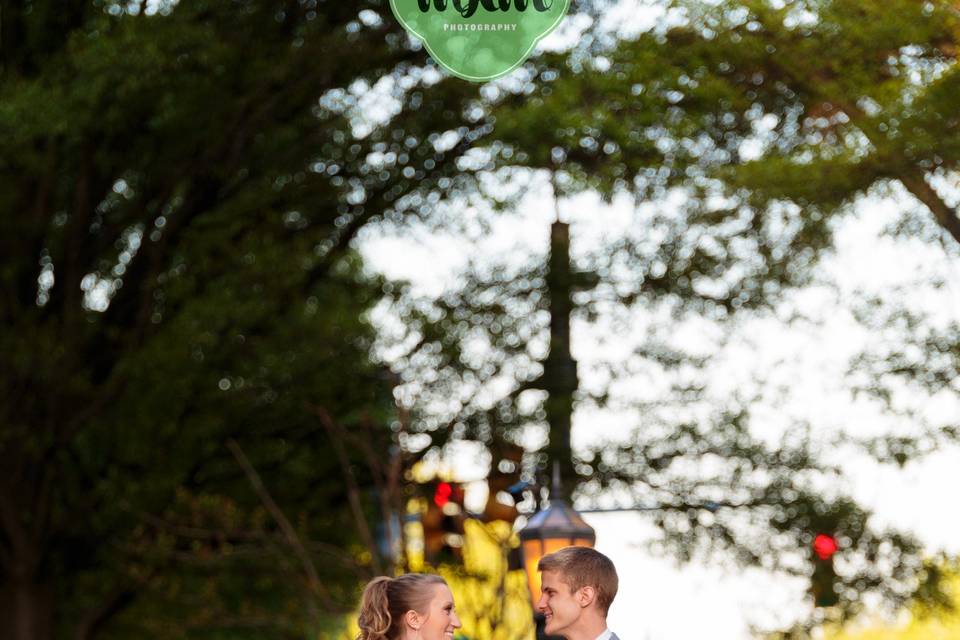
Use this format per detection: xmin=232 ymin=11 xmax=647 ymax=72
xmin=0 ymin=1 xmax=484 ymax=640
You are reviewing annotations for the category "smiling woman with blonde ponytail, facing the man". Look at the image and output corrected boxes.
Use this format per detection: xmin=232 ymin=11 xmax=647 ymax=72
xmin=357 ymin=573 xmax=461 ymax=640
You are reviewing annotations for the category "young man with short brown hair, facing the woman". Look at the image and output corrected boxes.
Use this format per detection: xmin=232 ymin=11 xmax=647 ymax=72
xmin=537 ymin=547 xmax=619 ymax=640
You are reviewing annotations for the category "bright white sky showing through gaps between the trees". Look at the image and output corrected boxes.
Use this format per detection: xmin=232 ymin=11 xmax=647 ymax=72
xmin=360 ymin=174 xmax=960 ymax=640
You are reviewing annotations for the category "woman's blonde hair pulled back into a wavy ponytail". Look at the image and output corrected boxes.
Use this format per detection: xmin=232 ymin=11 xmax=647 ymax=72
xmin=357 ymin=573 xmax=447 ymax=640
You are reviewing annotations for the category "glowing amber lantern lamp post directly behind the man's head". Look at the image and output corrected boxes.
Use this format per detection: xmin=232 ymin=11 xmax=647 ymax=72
xmin=520 ymin=462 xmax=597 ymax=640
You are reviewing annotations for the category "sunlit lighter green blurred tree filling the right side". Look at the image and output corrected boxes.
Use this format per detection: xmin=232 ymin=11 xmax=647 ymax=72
xmin=472 ymin=1 xmax=960 ymax=633
